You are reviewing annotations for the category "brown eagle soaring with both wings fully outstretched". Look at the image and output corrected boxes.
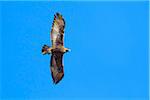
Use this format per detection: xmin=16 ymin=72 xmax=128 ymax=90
xmin=42 ymin=13 xmax=70 ymax=84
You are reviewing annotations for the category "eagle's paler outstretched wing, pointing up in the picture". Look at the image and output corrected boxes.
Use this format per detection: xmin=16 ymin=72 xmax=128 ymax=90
xmin=51 ymin=13 xmax=65 ymax=48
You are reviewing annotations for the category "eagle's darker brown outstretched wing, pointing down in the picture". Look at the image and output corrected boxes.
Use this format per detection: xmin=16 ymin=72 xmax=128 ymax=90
xmin=50 ymin=51 xmax=64 ymax=84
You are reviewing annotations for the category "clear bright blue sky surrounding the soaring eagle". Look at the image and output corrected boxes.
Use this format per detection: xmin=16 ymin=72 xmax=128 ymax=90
xmin=0 ymin=2 xmax=148 ymax=100
